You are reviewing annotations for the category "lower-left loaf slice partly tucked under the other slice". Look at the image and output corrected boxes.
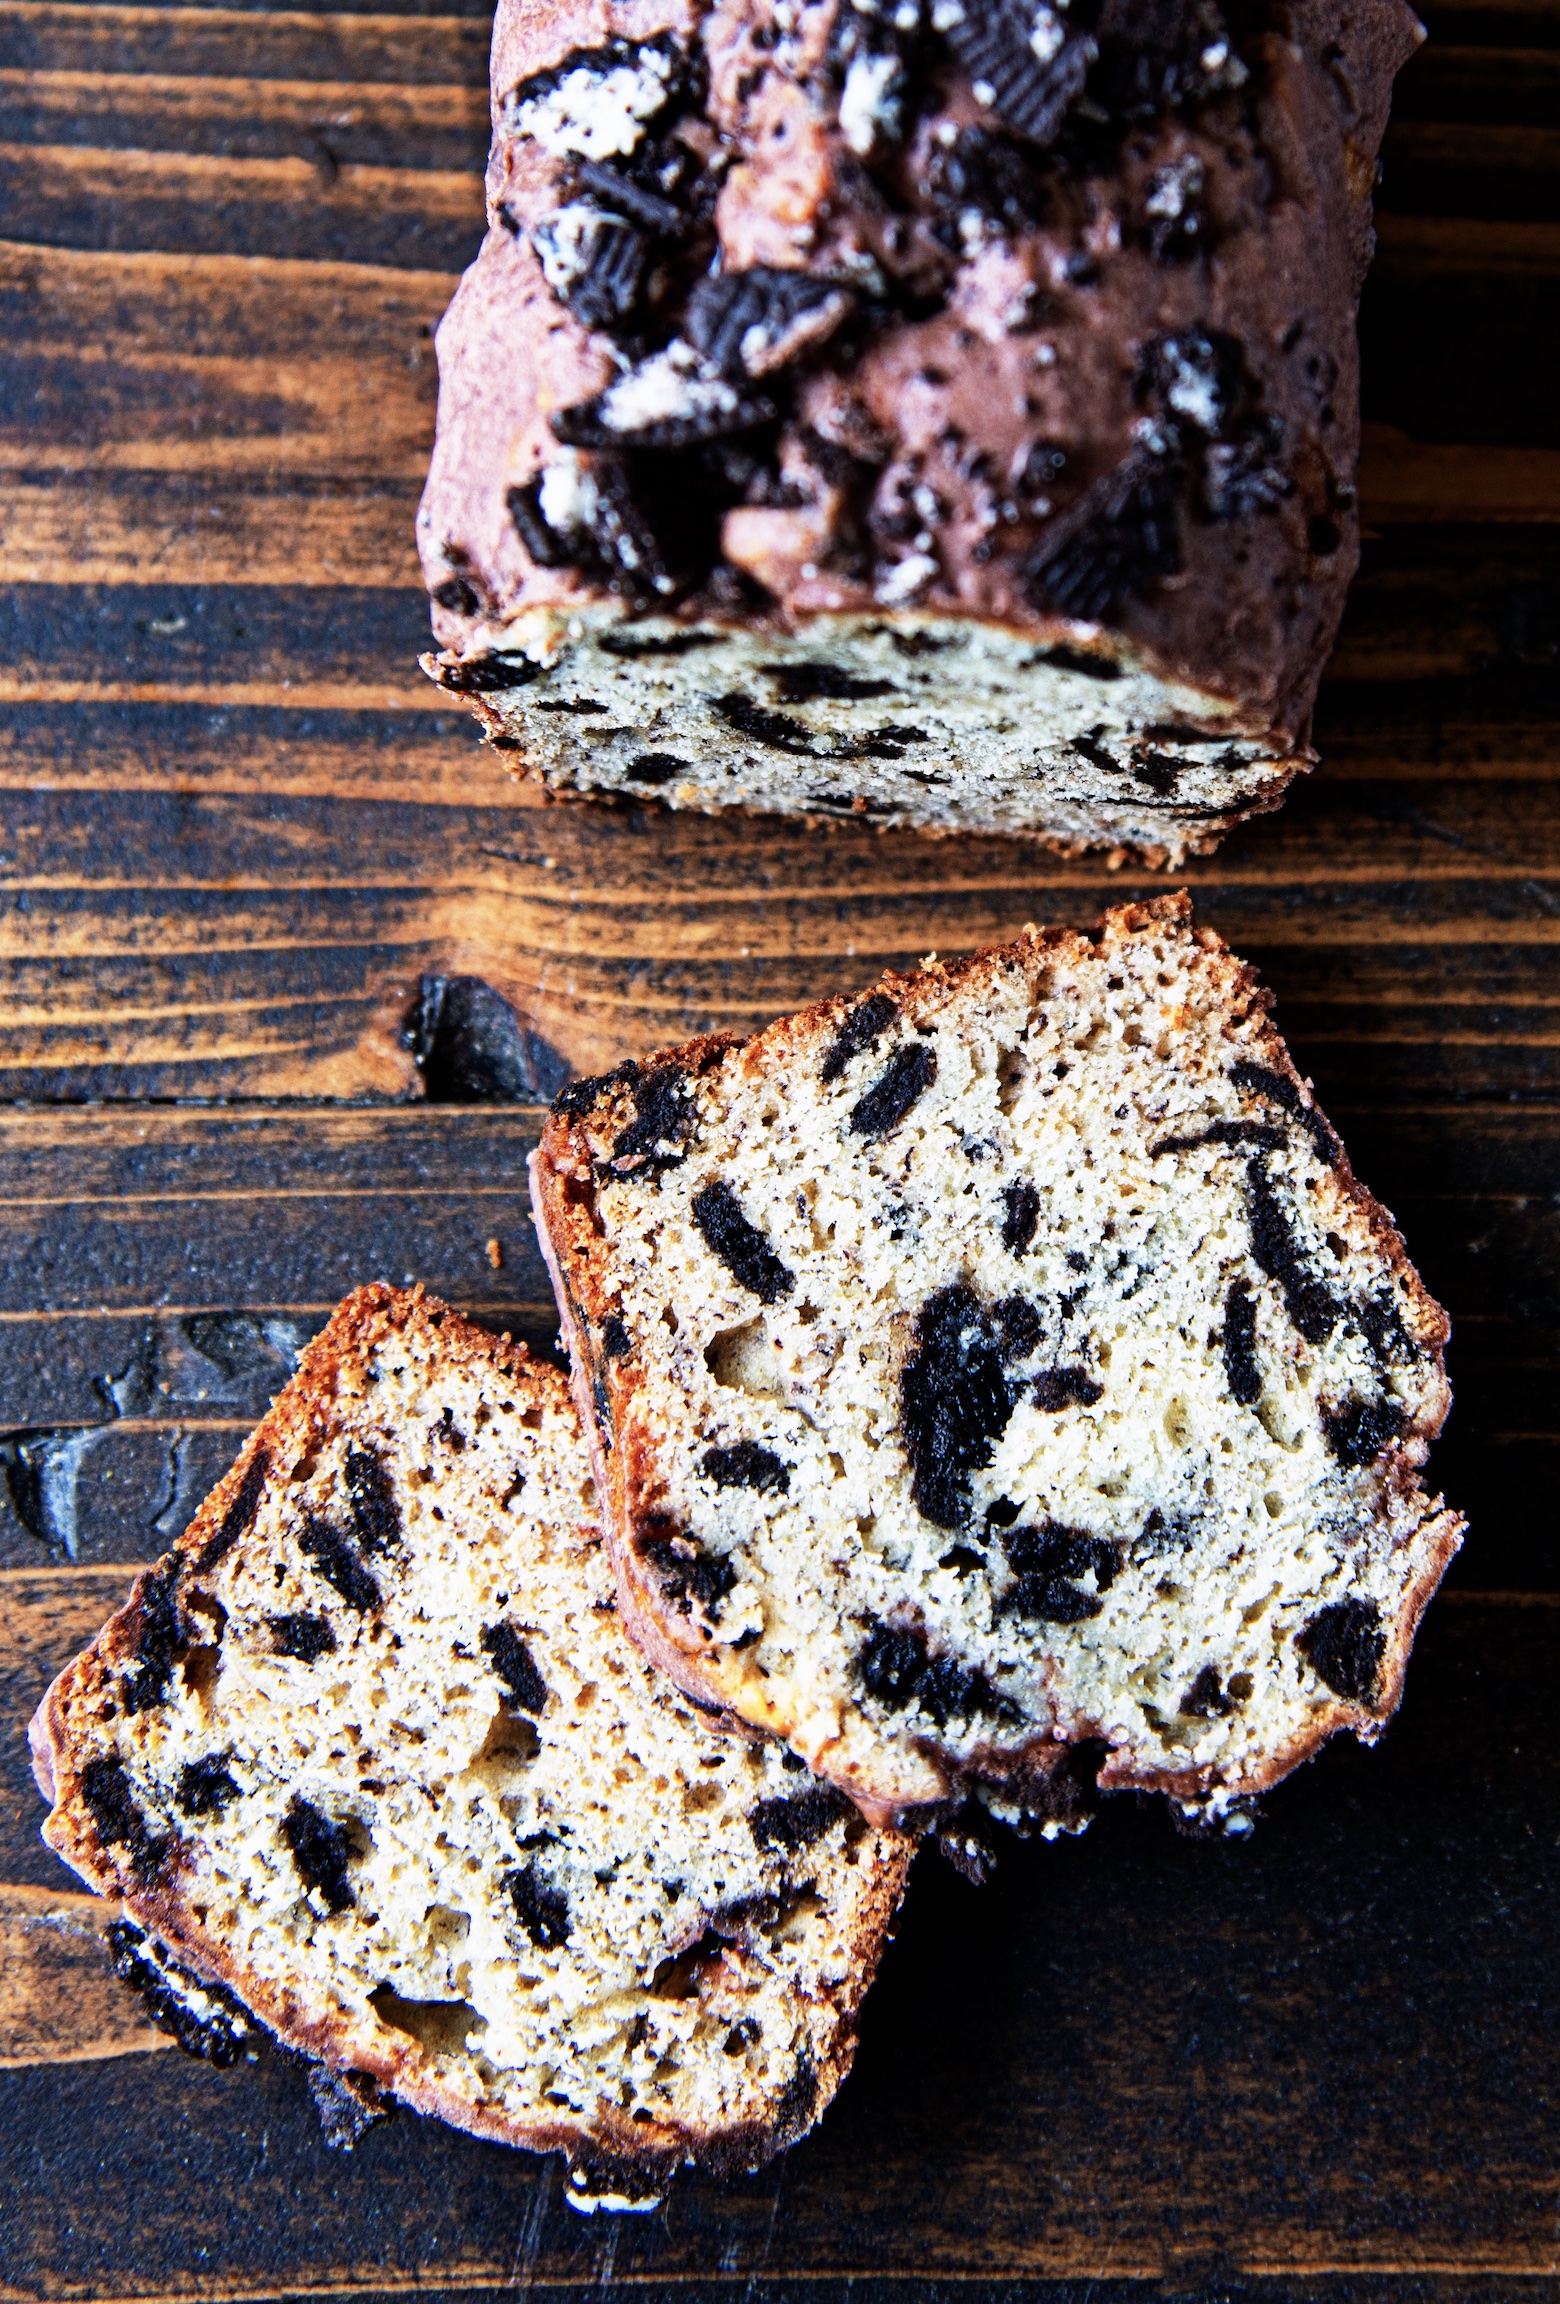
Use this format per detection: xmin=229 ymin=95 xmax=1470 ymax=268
xmin=32 ymin=1286 xmax=910 ymax=2205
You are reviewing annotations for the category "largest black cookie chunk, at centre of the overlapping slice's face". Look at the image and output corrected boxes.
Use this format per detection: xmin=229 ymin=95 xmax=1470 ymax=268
xmin=899 ymin=1281 xmax=1014 ymax=1530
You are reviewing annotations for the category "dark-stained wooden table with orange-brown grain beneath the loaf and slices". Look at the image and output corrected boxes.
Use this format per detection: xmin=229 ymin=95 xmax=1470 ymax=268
xmin=0 ymin=0 xmax=1560 ymax=2304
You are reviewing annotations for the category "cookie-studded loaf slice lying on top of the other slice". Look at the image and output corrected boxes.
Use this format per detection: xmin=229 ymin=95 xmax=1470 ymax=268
xmin=535 ymin=894 xmax=1461 ymax=1827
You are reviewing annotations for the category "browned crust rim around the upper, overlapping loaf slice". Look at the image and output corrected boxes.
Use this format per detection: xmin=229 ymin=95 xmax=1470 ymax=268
xmin=530 ymin=889 xmax=1463 ymax=1827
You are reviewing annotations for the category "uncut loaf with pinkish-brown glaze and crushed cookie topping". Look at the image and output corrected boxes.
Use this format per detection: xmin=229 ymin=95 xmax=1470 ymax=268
xmin=419 ymin=0 xmax=1417 ymax=857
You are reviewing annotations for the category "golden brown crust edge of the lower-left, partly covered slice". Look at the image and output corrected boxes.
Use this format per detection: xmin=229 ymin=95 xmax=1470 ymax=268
xmin=30 ymin=1281 xmax=915 ymax=2193
